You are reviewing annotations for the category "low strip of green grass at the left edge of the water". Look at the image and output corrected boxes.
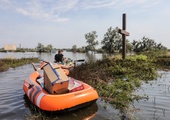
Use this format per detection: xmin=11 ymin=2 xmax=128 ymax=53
xmin=0 ymin=58 xmax=39 ymax=72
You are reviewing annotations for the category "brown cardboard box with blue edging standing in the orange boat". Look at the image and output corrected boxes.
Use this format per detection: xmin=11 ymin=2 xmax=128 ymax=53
xmin=43 ymin=63 xmax=69 ymax=94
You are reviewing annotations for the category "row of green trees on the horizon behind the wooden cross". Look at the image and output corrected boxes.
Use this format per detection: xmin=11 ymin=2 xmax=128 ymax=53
xmin=71 ymin=27 xmax=167 ymax=55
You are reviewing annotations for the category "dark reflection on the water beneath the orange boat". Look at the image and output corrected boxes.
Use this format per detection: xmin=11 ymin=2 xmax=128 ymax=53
xmin=23 ymin=95 xmax=98 ymax=120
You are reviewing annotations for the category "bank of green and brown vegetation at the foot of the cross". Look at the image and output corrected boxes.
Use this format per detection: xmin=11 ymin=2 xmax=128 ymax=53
xmin=70 ymin=53 xmax=170 ymax=113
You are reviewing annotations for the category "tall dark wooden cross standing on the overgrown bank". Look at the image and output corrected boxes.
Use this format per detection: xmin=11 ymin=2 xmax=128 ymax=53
xmin=119 ymin=13 xmax=130 ymax=59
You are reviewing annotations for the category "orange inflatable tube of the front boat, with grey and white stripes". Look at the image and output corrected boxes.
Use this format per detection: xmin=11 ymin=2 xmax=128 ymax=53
xmin=23 ymin=71 xmax=98 ymax=111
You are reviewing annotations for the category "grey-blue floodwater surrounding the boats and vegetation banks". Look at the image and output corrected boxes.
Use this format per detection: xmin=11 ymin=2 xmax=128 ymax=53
xmin=0 ymin=52 xmax=170 ymax=120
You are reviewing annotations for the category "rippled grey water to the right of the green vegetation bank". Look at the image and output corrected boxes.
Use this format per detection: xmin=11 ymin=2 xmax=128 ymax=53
xmin=134 ymin=72 xmax=170 ymax=120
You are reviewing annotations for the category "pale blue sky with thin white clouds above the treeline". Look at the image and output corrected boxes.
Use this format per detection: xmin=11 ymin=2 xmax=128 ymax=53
xmin=0 ymin=0 xmax=170 ymax=48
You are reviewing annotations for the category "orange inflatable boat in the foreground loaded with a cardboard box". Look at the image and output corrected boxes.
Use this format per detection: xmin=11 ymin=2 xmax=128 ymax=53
xmin=23 ymin=63 xmax=98 ymax=111
